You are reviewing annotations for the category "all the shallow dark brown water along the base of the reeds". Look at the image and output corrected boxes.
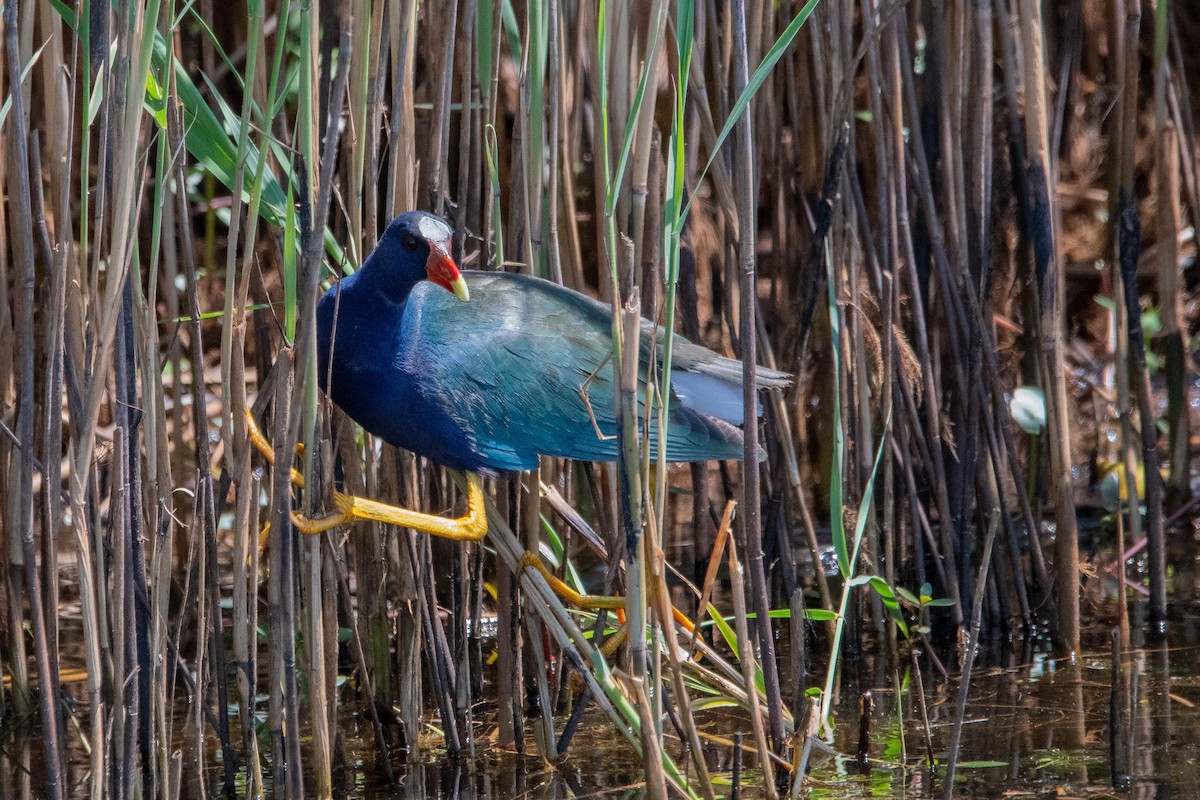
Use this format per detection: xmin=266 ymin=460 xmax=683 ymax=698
xmin=7 ymin=573 xmax=1200 ymax=800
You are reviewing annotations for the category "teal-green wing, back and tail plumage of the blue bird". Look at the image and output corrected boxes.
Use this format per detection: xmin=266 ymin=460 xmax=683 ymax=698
xmin=406 ymin=272 xmax=786 ymax=469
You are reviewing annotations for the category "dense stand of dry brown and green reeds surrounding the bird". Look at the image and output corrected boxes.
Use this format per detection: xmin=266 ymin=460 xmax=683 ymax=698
xmin=0 ymin=0 xmax=1196 ymax=798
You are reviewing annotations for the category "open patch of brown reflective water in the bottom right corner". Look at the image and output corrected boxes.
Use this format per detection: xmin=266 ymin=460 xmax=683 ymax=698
xmin=811 ymin=621 xmax=1200 ymax=800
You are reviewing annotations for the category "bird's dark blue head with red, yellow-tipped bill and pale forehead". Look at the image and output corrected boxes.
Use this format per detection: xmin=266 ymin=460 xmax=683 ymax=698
xmin=373 ymin=211 xmax=470 ymax=300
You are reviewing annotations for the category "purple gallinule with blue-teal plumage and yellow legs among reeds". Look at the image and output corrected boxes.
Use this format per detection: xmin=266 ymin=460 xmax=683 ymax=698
xmin=251 ymin=211 xmax=790 ymax=540
